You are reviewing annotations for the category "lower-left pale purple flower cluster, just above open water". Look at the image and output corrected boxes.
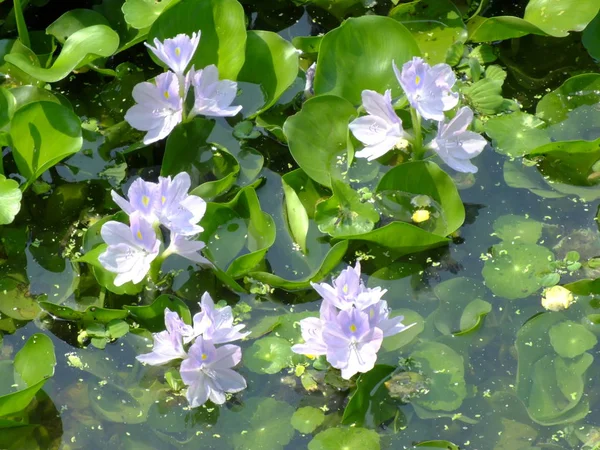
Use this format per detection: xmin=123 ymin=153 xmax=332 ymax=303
xmin=136 ymin=292 xmax=250 ymax=408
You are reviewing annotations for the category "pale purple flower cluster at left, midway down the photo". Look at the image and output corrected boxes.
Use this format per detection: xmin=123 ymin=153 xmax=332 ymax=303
xmin=98 ymin=172 xmax=210 ymax=286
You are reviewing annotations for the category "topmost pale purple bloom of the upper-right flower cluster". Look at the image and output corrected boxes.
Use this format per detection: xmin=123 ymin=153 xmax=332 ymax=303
xmin=392 ymin=57 xmax=458 ymax=121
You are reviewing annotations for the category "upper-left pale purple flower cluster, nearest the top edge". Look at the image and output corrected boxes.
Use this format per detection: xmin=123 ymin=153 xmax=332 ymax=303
xmin=125 ymin=32 xmax=242 ymax=144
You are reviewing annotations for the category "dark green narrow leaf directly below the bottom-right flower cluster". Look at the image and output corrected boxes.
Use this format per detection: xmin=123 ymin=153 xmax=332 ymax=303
xmin=342 ymin=364 xmax=395 ymax=426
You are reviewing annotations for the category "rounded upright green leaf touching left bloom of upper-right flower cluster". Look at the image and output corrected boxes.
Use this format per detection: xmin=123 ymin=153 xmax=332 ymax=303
xmin=283 ymin=94 xmax=356 ymax=187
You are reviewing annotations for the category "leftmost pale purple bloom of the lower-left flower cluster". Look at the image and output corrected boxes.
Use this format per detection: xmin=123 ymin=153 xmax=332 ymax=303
xmin=136 ymin=308 xmax=191 ymax=366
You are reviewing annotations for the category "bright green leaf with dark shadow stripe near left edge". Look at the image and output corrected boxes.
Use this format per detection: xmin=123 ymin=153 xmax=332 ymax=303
xmin=10 ymin=101 xmax=83 ymax=184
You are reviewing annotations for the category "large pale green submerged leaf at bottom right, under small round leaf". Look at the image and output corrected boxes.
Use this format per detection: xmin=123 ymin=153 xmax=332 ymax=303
xmin=516 ymin=313 xmax=594 ymax=426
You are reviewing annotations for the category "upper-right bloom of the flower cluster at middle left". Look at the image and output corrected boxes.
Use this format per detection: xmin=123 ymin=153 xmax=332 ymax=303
xmin=156 ymin=172 xmax=206 ymax=236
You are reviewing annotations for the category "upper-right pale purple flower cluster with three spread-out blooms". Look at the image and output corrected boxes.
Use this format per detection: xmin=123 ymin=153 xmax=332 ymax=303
xmin=350 ymin=58 xmax=487 ymax=173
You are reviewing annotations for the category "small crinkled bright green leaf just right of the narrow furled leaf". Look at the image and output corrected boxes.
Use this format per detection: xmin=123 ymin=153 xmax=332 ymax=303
xmin=315 ymin=180 xmax=379 ymax=237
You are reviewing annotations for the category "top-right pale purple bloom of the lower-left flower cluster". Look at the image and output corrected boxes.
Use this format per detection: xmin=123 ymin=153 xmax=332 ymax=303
xmin=184 ymin=292 xmax=250 ymax=344
